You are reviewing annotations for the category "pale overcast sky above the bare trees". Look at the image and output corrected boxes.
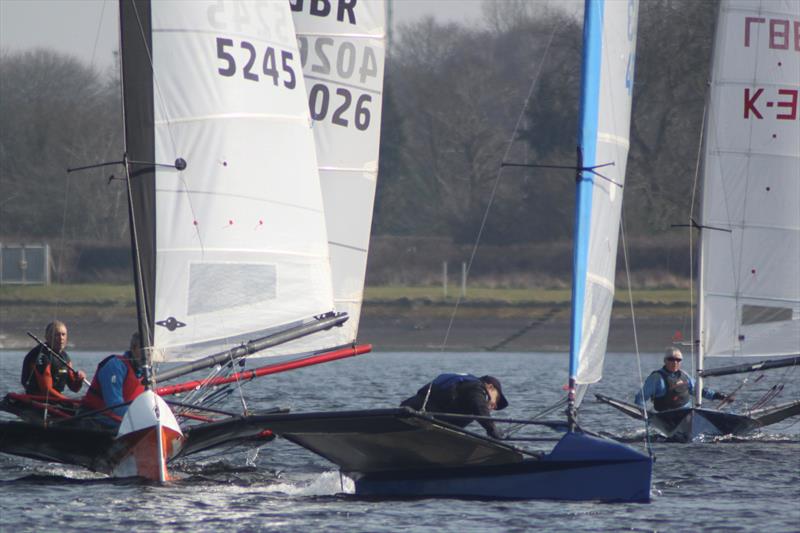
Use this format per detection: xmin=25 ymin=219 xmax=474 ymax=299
xmin=0 ymin=0 xmax=496 ymax=67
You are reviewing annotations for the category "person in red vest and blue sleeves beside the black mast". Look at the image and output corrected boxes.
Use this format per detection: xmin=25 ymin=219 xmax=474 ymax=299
xmin=81 ymin=332 xmax=145 ymax=425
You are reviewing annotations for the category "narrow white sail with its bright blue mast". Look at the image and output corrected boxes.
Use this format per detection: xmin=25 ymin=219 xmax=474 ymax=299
xmin=570 ymin=0 xmax=639 ymax=384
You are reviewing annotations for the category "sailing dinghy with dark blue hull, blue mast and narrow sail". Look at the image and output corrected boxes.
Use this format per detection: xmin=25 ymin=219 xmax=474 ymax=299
xmin=252 ymin=0 xmax=653 ymax=502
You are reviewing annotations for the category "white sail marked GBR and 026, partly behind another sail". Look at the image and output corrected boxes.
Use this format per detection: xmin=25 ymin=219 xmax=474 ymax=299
xmin=291 ymin=0 xmax=386 ymax=346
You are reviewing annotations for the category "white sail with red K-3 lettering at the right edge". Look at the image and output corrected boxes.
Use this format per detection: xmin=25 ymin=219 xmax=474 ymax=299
xmin=700 ymin=0 xmax=800 ymax=357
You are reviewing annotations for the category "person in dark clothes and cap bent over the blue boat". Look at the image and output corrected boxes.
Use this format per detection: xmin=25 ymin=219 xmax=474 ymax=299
xmin=400 ymin=374 xmax=508 ymax=439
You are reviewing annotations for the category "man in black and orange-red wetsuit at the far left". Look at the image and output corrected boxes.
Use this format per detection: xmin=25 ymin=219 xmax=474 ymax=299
xmin=20 ymin=320 xmax=86 ymax=399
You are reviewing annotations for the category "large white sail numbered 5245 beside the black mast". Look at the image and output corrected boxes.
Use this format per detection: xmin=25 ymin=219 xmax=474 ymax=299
xmin=142 ymin=0 xmax=333 ymax=360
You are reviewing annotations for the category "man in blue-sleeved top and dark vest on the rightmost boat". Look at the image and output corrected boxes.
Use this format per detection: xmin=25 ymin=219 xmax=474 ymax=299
xmin=634 ymin=348 xmax=728 ymax=411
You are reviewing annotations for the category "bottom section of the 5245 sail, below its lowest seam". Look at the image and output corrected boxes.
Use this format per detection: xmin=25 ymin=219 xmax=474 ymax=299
xmin=156 ymin=252 xmax=332 ymax=359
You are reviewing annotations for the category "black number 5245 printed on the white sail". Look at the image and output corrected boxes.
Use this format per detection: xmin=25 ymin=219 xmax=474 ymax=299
xmin=217 ymin=37 xmax=297 ymax=89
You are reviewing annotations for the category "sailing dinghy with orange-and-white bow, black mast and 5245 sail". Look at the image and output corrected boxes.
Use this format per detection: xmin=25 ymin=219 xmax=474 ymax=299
xmin=0 ymin=0 xmax=382 ymax=481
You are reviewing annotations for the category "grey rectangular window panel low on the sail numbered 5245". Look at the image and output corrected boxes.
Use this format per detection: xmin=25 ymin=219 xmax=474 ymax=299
xmin=187 ymin=263 xmax=277 ymax=316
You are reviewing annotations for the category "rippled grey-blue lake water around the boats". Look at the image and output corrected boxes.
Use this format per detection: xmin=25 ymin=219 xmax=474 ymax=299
xmin=0 ymin=352 xmax=800 ymax=532
